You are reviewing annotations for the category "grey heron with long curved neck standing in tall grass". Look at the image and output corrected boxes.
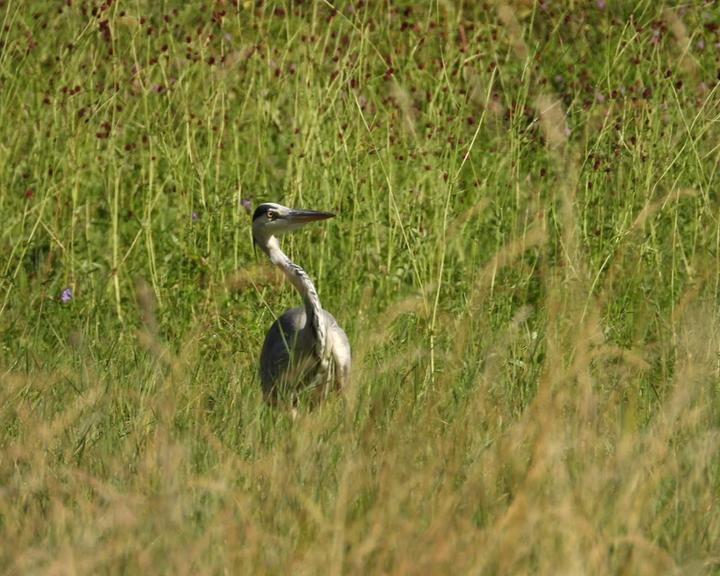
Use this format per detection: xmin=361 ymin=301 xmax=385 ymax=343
xmin=252 ymin=203 xmax=350 ymax=402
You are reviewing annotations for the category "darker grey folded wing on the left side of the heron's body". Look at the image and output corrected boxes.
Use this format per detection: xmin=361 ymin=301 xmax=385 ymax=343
xmin=260 ymin=308 xmax=306 ymax=395
